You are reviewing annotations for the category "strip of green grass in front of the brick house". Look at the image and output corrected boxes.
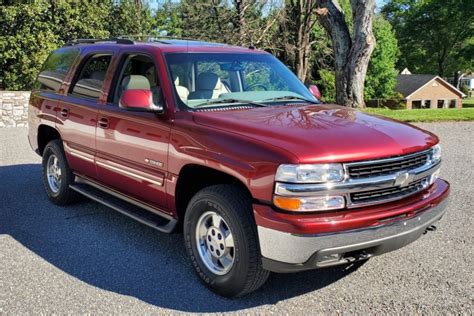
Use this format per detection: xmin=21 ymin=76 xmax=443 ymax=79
xmin=364 ymin=106 xmax=474 ymax=122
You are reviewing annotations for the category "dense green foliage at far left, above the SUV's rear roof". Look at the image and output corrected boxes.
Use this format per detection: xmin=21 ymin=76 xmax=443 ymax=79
xmin=0 ymin=0 xmax=161 ymax=90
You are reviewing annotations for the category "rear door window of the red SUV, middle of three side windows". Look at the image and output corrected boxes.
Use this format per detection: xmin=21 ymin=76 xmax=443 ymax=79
xmin=71 ymin=54 xmax=112 ymax=99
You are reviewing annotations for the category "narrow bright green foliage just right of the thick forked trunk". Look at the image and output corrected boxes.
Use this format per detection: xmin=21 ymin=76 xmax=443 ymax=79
xmin=364 ymin=16 xmax=399 ymax=100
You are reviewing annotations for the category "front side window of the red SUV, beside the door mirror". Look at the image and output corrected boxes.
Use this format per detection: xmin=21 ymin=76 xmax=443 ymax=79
xmin=113 ymin=54 xmax=160 ymax=104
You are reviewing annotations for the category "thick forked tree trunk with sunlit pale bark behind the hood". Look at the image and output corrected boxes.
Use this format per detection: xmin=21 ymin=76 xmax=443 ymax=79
xmin=317 ymin=0 xmax=375 ymax=108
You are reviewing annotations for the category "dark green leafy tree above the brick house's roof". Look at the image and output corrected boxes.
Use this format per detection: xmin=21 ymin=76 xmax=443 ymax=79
xmin=382 ymin=0 xmax=474 ymax=76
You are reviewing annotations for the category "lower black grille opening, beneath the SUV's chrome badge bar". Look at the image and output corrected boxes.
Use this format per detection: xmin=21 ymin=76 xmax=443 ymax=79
xmin=350 ymin=178 xmax=429 ymax=206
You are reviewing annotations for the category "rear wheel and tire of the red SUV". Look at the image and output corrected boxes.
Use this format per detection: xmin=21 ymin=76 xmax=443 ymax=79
xmin=43 ymin=139 xmax=78 ymax=205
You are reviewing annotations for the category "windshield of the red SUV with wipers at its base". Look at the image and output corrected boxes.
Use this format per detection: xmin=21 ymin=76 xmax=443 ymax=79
xmin=166 ymin=53 xmax=316 ymax=108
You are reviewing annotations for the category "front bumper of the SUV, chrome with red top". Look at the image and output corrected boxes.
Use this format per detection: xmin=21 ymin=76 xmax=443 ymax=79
xmin=257 ymin=180 xmax=449 ymax=272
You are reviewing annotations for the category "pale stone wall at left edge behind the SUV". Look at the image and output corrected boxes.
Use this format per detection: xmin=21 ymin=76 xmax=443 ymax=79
xmin=0 ymin=91 xmax=30 ymax=127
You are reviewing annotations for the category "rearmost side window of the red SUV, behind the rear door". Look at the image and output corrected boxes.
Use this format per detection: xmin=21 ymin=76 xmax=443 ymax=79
xmin=34 ymin=48 xmax=79 ymax=92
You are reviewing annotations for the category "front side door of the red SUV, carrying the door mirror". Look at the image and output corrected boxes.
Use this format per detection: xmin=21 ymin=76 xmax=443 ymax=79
xmin=96 ymin=49 xmax=171 ymax=212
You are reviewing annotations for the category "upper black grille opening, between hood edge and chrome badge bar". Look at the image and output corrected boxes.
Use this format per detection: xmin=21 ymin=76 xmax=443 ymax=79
xmin=347 ymin=151 xmax=430 ymax=179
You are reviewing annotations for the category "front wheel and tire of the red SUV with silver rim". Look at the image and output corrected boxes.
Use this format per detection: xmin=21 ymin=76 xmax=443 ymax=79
xmin=184 ymin=185 xmax=270 ymax=297
